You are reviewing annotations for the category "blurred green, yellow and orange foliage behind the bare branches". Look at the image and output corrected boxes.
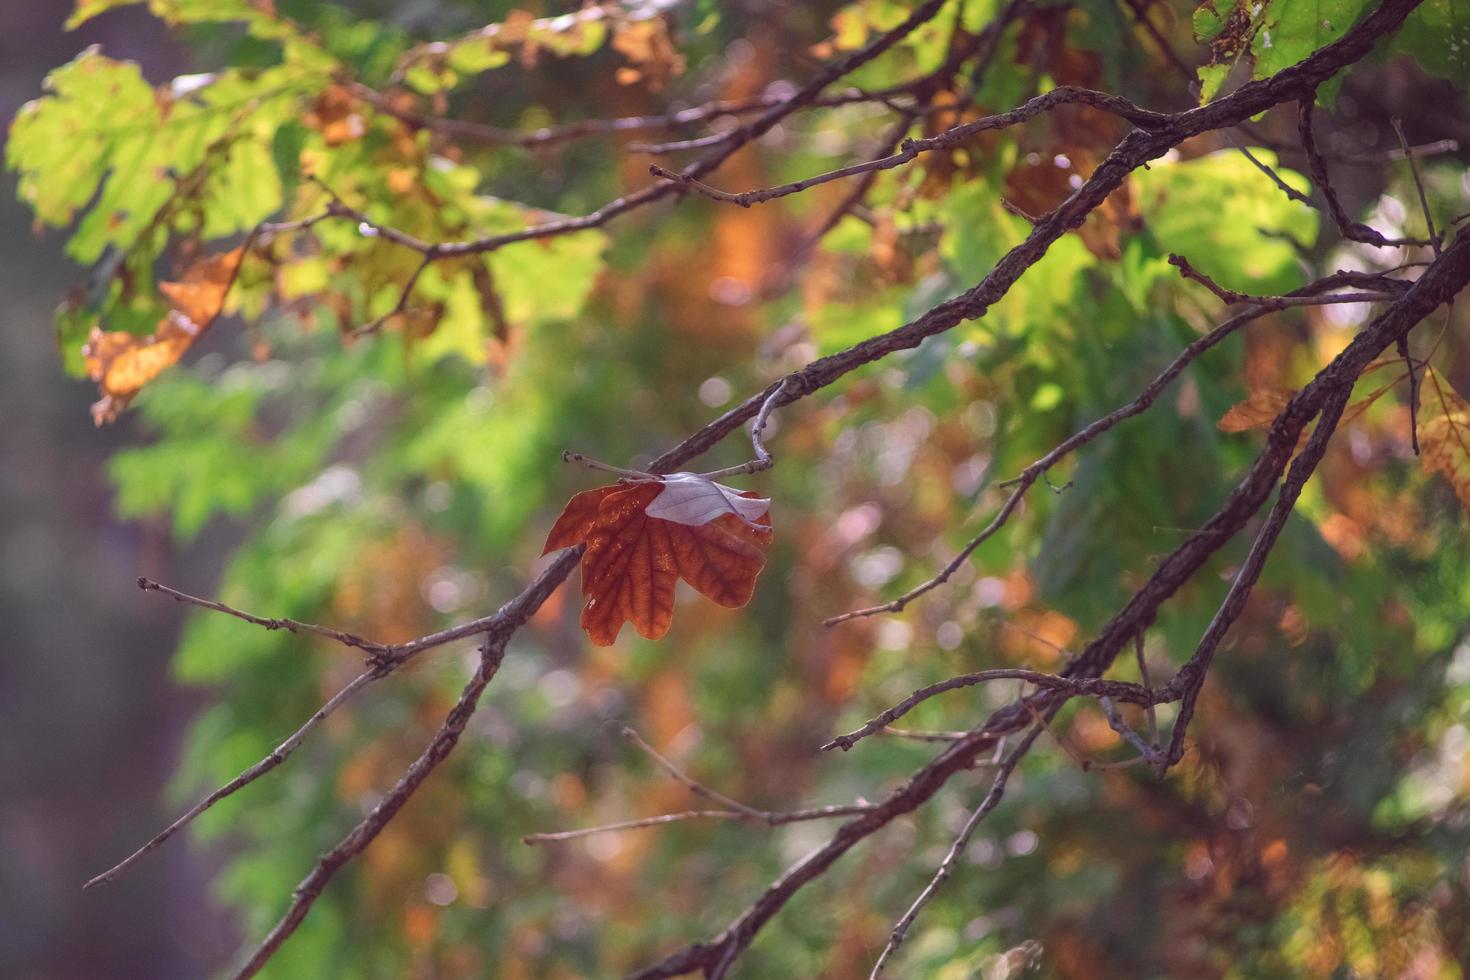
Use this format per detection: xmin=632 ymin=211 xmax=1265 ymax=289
xmin=0 ymin=0 xmax=1470 ymax=977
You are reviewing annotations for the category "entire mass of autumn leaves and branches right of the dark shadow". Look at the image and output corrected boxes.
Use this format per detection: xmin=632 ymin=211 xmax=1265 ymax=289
xmin=11 ymin=0 xmax=1470 ymax=980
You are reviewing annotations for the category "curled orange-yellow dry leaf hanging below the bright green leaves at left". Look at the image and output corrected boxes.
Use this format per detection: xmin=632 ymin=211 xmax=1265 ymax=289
xmin=82 ymin=248 xmax=241 ymax=425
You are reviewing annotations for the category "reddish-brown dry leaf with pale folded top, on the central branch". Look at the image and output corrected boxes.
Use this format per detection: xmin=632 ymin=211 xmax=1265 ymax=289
xmin=542 ymin=473 xmax=772 ymax=646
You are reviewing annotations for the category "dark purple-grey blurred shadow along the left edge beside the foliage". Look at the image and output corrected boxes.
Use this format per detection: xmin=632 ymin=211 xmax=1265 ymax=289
xmin=0 ymin=0 xmax=235 ymax=980
